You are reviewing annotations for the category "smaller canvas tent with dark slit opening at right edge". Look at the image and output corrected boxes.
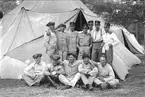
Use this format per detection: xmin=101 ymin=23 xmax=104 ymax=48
xmin=111 ymin=25 xmax=144 ymax=54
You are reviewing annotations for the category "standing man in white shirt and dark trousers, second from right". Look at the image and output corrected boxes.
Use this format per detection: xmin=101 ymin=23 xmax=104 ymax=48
xmin=91 ymin=21 xmax=104 ymax=62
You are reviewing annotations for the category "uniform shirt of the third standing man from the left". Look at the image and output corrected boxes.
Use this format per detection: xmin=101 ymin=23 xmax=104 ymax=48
xmin=68 ymin=31 xmax=78 ymax=51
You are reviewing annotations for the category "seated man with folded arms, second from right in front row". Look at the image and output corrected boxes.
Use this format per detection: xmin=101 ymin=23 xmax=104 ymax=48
xmin=78 ymin=54 xmax=98 ymax=90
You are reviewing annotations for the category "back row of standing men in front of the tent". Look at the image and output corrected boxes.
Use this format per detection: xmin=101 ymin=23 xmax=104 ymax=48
xmin=44 ymin=21 xmax=118 ymax=64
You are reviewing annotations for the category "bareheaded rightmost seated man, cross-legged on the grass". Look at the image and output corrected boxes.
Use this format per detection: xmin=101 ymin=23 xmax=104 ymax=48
xmin=94 ymin=55 xmax=119 ymax=89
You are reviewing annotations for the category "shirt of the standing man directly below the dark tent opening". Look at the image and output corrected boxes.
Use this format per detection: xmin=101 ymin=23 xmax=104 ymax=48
xmin=77 ymin=33 xmax=92 ymax=46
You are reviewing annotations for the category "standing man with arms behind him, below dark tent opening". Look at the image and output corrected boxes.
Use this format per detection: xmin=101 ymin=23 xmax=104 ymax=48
xmin=77 ymin=25 xmax=92 ymax=59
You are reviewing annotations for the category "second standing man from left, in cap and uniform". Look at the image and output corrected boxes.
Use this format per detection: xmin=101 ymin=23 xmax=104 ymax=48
xmin=56 ymin=24 xmax=68 ymax=61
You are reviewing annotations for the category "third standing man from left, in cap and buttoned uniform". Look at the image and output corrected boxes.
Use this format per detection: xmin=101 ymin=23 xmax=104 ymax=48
xmin=68 ymin=22 xmax=78 ymax=55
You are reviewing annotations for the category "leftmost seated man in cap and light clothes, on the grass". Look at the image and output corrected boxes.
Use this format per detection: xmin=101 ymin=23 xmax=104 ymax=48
xmin=22 ymin=53 xmax=46 ymax=86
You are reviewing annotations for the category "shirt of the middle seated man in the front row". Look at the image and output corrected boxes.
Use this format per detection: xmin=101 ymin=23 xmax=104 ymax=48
xmin=63 ymin=60 xmax=78 ymax=77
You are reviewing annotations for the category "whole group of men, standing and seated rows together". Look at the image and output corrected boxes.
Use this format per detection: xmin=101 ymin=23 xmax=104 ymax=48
xmin=23 ymin=21 xmax=119 ymax=90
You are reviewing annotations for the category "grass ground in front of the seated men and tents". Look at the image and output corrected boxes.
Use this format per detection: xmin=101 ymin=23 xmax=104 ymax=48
xmin=0 ymin=57 xmax=145 ymax=97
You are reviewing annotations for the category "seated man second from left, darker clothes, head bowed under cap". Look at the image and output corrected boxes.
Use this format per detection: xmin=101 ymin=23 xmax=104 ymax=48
xmin=44 ymin=54 xmax=65 ymax=88
